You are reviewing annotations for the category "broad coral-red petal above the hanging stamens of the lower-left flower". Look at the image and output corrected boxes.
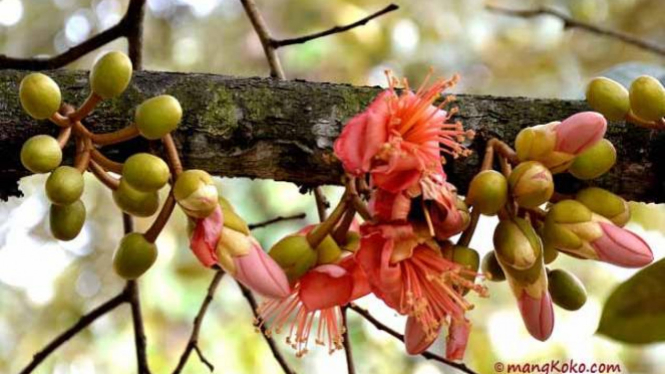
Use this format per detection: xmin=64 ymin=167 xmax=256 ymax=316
xmin=299 ymin=265 xmax=353 ymax=312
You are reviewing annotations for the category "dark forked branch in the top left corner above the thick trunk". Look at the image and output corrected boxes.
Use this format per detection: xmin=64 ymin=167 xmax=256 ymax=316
xmin=0 ymin=0 xmax=145 ymax=70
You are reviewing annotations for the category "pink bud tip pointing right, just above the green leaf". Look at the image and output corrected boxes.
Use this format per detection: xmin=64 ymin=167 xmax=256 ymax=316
xmin=591 ymin=222 xmax=653 ymax=268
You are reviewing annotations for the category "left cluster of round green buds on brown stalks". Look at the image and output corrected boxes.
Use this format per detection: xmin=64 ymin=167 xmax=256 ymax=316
xmin=19 ymin=52 xmax=201 ymax=279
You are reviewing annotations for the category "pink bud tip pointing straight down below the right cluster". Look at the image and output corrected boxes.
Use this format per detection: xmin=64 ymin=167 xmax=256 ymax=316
xmin=517 ymin=291 xmax=554 ymax=341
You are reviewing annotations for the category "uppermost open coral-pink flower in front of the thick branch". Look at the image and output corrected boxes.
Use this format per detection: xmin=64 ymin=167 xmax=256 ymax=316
xmin=334 ymin=72 xmax=472 ymax=193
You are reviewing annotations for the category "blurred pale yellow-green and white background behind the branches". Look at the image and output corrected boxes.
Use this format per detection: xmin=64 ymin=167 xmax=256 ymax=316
xmin=0 ymin=0 xmax=665 ymax=374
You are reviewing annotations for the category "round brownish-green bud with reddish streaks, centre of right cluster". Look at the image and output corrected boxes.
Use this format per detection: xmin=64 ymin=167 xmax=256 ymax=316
xmin=508 ymin=161 xmax=554 ymax=208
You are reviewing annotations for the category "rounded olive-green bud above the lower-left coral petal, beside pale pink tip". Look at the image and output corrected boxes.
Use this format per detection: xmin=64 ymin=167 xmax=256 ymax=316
xmin=268 ymin=235 xmax=318 ymax=283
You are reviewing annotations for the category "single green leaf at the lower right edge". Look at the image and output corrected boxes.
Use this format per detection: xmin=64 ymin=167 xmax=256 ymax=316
xmin=597 ymin=259 xmax=665 ymax=344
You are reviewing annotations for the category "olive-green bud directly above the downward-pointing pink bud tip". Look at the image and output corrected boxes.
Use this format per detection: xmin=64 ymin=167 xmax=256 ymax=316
xmin=493 ymin=217 xmax=543 ymax=270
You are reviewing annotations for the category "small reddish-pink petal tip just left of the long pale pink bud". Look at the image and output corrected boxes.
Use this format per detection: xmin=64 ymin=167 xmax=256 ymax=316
xmin=189 ymin=206 xmax=224 ymax=267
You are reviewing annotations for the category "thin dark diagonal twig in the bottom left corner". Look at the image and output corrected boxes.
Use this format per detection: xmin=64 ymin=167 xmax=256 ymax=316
xmin=19 ymin=291 xmax=128 ymax=374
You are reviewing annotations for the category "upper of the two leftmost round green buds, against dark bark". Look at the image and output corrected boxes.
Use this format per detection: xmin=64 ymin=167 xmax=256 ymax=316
xmin=19 ymin=73 xmax=62 ymax=119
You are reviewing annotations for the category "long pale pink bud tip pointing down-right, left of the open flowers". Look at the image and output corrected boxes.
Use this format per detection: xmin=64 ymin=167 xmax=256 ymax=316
xmin=234 ymin=236 xmax=291 ymax=299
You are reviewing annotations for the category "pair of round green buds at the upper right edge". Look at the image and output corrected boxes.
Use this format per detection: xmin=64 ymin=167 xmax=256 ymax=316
xmin=586 ymin=75 xmax=665 ymax=125
